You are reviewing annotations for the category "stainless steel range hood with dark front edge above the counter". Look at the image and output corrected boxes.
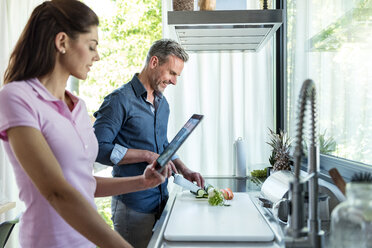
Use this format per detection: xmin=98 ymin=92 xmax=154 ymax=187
xmin=168 ymin=9 xmax=283 ymax=52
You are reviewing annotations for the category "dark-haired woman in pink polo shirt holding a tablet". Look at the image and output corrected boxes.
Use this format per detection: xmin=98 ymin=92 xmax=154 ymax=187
xmin=0 ymin=0 xmax=170 ymax=248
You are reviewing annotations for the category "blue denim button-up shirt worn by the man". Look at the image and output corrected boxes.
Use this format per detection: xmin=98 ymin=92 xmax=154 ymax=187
xmin=94 ymin=74 xmax=177 ymax=213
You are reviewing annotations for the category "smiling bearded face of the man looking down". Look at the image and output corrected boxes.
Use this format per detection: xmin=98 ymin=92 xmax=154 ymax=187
xmin=150 ymin=55 xmax=184 ymax=93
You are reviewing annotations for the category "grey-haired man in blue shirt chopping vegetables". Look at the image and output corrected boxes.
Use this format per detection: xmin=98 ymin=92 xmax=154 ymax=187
xmin=94 ymin=39 xmax=204 ymax=248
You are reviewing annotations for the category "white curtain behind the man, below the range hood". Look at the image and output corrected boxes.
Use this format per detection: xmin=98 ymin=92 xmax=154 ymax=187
xmin=163 ymin=0 xmax=274 ymax=176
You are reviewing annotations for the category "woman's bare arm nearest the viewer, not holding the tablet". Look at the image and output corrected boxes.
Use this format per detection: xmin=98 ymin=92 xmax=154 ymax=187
xmin=7 ymin=127 xmax=131 ymax=248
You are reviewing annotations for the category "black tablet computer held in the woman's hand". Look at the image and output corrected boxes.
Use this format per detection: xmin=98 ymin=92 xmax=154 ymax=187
xmin=155 ymin=114 xmax=203 ymax=172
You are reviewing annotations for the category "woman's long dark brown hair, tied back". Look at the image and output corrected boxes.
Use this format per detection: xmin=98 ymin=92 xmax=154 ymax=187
xmin=4 ymin=0 xmax=99 ymax=84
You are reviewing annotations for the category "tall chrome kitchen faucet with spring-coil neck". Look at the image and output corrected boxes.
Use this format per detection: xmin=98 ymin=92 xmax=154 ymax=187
xmin=285 ymin=79 xmax=324 ymax=248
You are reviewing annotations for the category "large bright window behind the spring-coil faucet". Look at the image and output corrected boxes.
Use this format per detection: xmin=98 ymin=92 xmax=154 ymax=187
xmin=286 ymin=0 xmax=372 ymax=168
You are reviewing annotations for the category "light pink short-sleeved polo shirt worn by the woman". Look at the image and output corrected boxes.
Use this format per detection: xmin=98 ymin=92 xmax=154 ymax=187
xmin=0 ymin=78 xmax=98 ymax=248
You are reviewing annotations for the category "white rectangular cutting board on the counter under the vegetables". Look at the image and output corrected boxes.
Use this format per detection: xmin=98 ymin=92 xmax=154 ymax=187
xmin=164 ymin=191 xmax=274 ymax=242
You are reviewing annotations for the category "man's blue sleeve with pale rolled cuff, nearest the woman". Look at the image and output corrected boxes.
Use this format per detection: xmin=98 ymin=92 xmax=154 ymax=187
xmin=94 ymin=93 xmax=128 ymax=166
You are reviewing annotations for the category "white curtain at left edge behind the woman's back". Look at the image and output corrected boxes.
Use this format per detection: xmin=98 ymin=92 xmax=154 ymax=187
xmin=0 ymin=0 xmax=43 ymax=247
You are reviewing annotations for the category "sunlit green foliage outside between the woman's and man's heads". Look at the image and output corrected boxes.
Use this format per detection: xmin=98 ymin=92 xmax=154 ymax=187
xmin=79 ymin=0 xmax=162 ymax=115
